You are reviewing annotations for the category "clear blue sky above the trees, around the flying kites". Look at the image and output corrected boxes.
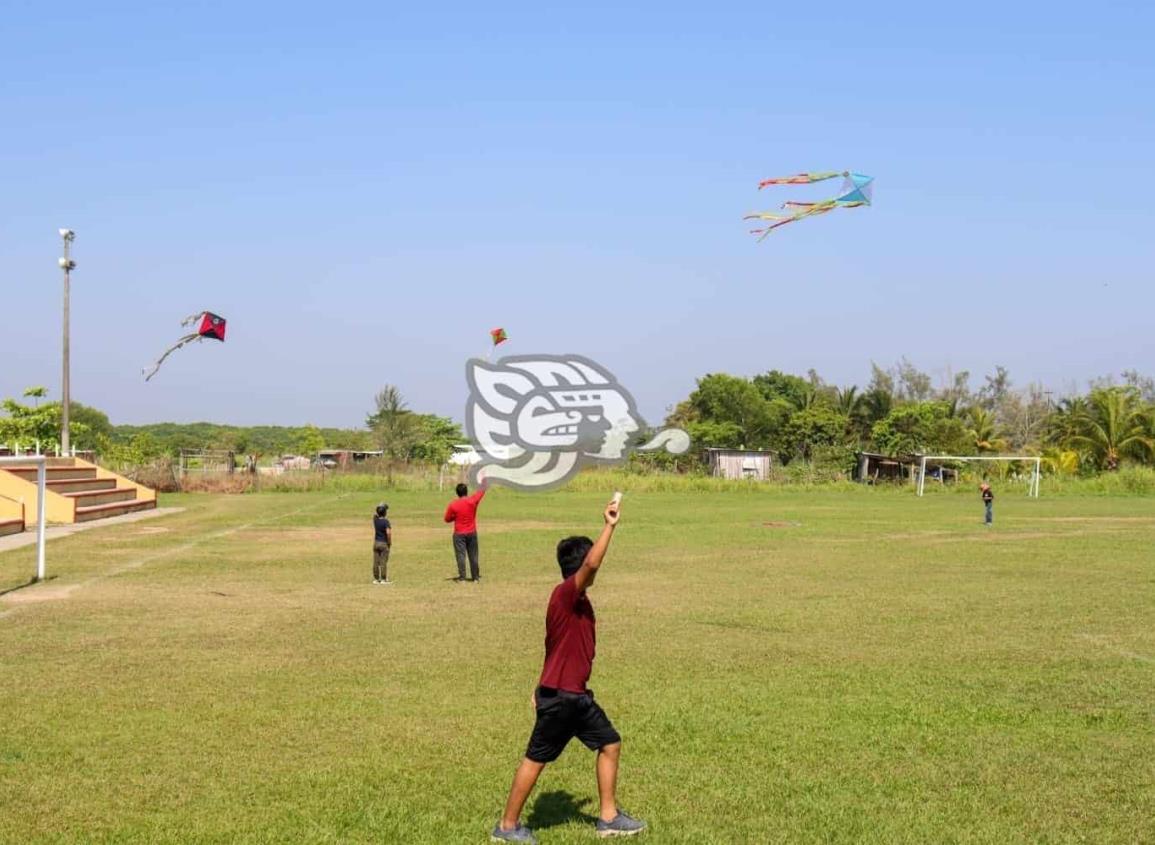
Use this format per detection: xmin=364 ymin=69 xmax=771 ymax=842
xmin=0 ymin=0 xmax=1155 ymax=426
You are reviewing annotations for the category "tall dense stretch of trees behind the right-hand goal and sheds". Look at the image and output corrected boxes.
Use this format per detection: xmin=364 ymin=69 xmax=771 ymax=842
xmin=666 ymin=359 xmax=1155 ymax=473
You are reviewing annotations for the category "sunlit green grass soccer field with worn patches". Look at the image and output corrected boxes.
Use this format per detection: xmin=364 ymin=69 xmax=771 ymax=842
xmin=0 ymin=489 xmax=1155 ymax=844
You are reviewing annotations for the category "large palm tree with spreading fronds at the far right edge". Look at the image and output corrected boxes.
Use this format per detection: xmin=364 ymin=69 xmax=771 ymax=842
xmin=1070 ymin=387 xmax=1155 ymax=470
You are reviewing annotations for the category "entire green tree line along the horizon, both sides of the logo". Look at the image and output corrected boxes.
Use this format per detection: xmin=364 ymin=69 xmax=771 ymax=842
xmin=0 ymin=367 xmax=1155 ymax=474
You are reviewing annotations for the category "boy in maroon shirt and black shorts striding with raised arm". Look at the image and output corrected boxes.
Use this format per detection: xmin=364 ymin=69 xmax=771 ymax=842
xmin=491 ymin=498 xmax=646 ymax=843
